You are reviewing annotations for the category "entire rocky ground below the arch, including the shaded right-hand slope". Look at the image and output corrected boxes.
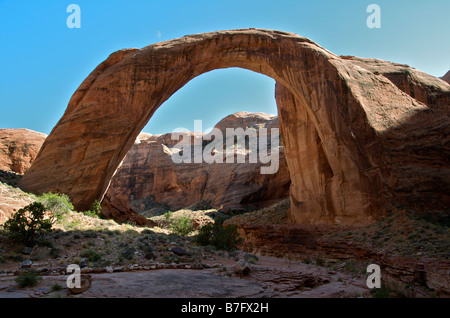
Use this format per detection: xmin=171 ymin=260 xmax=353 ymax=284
xmin=0 ymin=179 xmax=449 ymax=298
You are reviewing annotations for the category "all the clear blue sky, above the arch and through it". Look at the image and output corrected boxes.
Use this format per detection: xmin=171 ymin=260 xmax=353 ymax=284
xmin=0 ymin=0 xmax=450 ymax=134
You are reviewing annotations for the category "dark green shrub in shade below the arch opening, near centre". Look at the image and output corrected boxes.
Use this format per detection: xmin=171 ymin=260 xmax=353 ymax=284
xmin=196 ymin=219 xmax=241 ymax=251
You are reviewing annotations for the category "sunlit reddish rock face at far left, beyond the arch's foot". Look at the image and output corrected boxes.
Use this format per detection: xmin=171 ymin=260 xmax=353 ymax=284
xmin=0 ymin=129 xmax=47 ymax=174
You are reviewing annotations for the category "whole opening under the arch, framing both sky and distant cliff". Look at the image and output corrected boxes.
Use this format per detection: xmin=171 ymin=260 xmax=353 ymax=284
xmin=103 ymin=69 xmax=290 ymax=219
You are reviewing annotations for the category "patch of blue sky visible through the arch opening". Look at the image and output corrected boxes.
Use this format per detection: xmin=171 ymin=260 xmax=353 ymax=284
xmin=142 ymin=68 xmax=278 ymax=135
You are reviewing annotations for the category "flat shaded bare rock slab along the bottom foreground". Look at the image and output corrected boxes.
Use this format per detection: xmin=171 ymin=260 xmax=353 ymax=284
xmin=0 ymin=252 xmax=372 ymax=298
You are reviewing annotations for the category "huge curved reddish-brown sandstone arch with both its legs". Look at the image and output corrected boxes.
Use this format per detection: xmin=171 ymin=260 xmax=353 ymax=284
xmin=20 ymin=29 xmax=448 ymax=224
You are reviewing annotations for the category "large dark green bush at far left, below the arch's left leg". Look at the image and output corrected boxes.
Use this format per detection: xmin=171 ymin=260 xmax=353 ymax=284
xmin=4 ymin=202 xmax=53 ymax=243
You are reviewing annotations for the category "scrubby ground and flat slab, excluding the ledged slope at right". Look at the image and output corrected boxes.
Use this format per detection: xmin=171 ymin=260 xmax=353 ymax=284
xmin=0 ymin=183 xmax=394 ymax=298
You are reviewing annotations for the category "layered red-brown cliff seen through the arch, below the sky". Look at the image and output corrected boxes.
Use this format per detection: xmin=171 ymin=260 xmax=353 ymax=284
xmin=105 ymin=112 xmax=290 ymax=211
